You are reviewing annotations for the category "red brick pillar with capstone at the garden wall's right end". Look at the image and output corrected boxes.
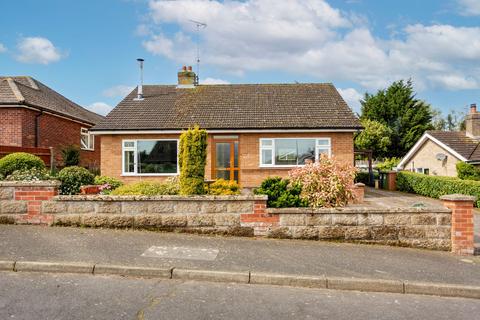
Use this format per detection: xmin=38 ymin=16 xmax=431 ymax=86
xmin=440 ymin=194 xmax=476 ymax=255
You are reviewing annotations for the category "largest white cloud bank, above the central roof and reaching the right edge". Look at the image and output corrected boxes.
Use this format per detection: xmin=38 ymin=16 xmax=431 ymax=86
xmin=143 ymin=0 xmax=480 ymax=90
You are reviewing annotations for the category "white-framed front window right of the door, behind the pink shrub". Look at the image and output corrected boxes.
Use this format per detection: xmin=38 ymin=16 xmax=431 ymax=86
xmin=260 ymin=138 xmax=332 ymax=167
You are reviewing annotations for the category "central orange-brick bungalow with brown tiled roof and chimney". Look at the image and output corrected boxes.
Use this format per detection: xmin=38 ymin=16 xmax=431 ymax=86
xmin=92 ymin=67 xmax=362 ymax=187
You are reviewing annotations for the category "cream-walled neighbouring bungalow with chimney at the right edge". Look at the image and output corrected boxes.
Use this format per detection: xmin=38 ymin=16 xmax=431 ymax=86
xmin=397 ymin=104 xmax=480 ymax=177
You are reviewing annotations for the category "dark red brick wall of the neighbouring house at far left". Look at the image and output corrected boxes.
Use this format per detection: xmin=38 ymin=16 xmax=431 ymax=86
xmin=0 ymin=108 xmax=101 ymax=166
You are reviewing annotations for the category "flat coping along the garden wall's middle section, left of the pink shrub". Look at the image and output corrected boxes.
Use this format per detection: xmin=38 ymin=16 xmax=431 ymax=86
xmin=53 ymin=195 xmax=268 ymax=201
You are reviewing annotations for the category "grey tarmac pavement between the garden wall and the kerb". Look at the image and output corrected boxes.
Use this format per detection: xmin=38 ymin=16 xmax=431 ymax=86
xmin=0 ymin=225 xmax=480 ymax=286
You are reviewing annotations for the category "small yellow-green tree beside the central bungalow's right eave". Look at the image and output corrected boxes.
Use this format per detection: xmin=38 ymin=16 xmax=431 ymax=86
xmin=355 ymin=119 xmax=393 ymax=158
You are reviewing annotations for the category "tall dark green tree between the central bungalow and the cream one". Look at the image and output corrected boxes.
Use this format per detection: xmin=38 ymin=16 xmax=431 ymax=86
xmin=361 ymin=80 xmax=433 ymax=157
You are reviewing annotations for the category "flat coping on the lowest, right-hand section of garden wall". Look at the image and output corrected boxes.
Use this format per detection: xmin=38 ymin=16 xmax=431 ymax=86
xmin=267 ymin=207 xmax=452 ymax=214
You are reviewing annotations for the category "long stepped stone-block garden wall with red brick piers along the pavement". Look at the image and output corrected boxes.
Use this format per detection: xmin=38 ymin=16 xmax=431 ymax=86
xmin=0 ymin=182 xmax=475 ymax=254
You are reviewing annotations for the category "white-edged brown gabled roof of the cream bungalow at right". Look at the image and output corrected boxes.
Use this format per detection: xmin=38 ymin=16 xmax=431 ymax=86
xmin=398 ymin=130 xmax=480 ymax=168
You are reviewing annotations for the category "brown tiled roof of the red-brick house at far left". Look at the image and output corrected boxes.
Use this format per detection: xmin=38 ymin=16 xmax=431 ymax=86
xmin=0 ymin=76 xmax=104 ymax=125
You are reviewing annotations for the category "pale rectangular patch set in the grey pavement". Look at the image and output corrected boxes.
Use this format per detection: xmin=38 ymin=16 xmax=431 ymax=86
xmin=142 ymin=246 xmax=218 ymax=261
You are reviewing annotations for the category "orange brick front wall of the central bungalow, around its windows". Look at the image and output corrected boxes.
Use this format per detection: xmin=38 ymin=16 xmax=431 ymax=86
xmin=101 ymin=132 xmax=353 ymax=187
